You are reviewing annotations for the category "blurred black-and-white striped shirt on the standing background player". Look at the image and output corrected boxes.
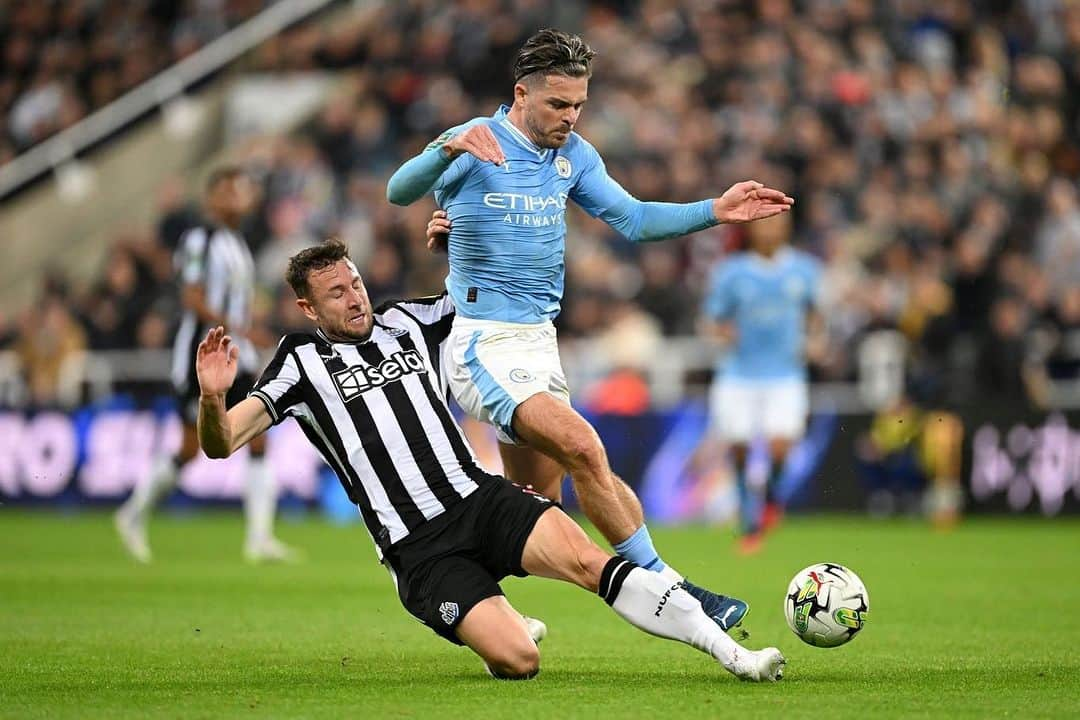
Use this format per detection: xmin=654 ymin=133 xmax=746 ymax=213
xmin=172 ymin=226 xmax=258 ymax=392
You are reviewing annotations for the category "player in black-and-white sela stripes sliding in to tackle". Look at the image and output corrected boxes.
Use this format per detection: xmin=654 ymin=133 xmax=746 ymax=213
xmin=197 ymin=241 xmax=785 ymax=681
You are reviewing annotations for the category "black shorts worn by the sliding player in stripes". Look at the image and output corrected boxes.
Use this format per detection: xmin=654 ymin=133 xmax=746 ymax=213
xmin=386 ymin=477 xmax=558 ymax=644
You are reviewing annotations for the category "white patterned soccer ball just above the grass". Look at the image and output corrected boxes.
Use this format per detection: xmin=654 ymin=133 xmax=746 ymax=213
xmin=784 ymin=562 xmax=870 ymax=648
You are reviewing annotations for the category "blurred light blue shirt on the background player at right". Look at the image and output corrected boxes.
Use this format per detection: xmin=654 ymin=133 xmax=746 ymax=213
xmin=704 ymin=247 xmax=821 ymax=380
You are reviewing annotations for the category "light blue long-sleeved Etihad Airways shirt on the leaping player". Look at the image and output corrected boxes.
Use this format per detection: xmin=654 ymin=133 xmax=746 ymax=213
xmin=387 ymin=106 xmax=716 ymax=324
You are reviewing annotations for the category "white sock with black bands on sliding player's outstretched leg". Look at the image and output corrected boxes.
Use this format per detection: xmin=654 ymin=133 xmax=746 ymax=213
xmin=598 ymin=557 xmax=751 ymax=673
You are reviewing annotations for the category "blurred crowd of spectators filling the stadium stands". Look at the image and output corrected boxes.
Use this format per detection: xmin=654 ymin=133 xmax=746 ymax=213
xmin=0 ymin=0 xmax=1080 ymax=405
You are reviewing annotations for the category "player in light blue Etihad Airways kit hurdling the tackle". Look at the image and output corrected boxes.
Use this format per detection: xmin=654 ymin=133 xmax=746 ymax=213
xmin=387 ymin=30 xmax=794 ymax=629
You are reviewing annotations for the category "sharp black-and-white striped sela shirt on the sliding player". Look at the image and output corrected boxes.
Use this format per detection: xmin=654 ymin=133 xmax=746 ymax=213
xmin=251 ymin=295 xmax=494 ymax=551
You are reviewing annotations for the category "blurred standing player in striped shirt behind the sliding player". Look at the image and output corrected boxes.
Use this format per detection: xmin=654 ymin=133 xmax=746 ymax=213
xmin=116 ymin=166 xmax=295 ymax=562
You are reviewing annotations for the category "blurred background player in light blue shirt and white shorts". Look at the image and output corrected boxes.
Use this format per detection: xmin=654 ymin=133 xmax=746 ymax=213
xmin=703 ymin=211 xmax=821 ymax=553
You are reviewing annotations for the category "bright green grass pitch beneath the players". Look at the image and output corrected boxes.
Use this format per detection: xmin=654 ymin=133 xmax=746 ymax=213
xmin=0 ymin=508 xmax=1080 ymax=720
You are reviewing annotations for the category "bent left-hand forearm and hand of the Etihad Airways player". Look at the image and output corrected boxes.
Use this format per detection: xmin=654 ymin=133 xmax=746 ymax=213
xmin=387 ymin=124 xmax=507 ymax=205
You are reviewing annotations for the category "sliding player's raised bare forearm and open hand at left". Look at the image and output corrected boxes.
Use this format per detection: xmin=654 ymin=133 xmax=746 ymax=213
xmin=195 ymin=326 xmax=271 ymax=458
